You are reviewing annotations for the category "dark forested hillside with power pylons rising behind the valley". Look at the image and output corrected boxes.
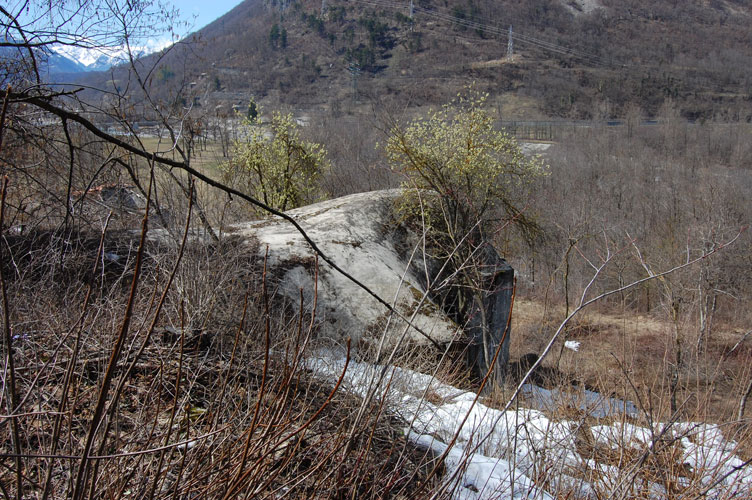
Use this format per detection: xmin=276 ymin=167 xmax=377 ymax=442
xmin=78 ymin=0 xmax=752 ymax=121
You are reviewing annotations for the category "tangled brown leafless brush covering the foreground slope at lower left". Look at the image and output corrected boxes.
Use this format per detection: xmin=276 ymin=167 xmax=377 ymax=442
xmin=0 ymin=213 xmax=440 ymax=498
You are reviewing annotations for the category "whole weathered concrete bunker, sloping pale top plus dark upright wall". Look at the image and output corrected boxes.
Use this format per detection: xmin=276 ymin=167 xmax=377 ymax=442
xmin=230 ymin=190 xmax=514 ymax=387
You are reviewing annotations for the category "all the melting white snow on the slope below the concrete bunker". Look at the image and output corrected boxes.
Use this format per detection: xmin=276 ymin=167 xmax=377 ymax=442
xmin=307 ymin=355 xmax=752 ymax=500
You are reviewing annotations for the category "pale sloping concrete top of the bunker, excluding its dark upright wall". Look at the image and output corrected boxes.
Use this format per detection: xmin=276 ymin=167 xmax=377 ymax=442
xmin=230 ymin=190 xmax=458 ymax=345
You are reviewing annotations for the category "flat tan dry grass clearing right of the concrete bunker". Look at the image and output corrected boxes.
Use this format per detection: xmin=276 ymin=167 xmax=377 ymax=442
xmin=510 ymin=300 xmax=752 ymax=430
